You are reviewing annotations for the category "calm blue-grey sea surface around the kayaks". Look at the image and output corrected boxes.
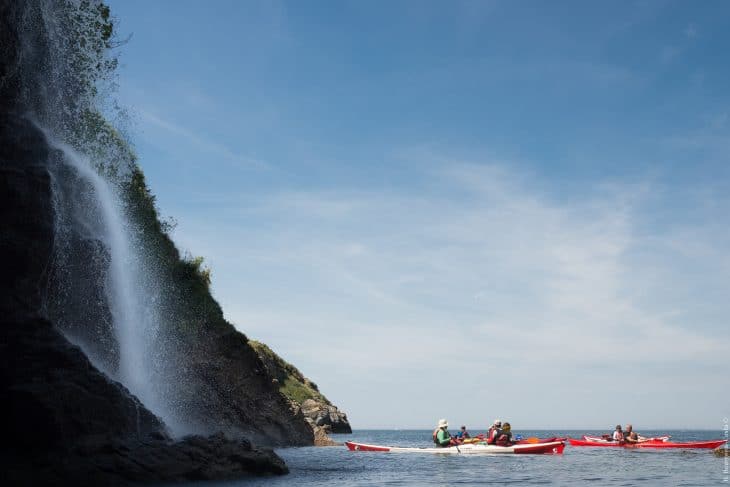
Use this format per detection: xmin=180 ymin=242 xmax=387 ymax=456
xmin=191 ymin=430 xmax=730 ymax=487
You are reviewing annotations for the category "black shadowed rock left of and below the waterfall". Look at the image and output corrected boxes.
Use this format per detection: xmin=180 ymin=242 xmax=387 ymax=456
xmin=0 ymin=112 xmax=286 ymax=485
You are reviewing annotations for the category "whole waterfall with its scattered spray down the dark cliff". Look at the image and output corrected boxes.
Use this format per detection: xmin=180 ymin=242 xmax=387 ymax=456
xmin=13 ymin=0 xmax=188 ymax=434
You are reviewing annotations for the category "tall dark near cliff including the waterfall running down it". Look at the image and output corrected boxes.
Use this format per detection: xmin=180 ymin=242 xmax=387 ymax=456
xmin=0 ymin=0 xmax=349 ymax=485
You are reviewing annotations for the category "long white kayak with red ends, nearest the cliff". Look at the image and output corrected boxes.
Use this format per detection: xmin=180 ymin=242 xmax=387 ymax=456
xmin=345 ymin=441 xmax=565 ymax=455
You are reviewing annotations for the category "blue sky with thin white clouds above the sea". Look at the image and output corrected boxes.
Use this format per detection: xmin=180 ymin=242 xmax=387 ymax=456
xmin=109 ymin=0 xmax=730 ymax=434
